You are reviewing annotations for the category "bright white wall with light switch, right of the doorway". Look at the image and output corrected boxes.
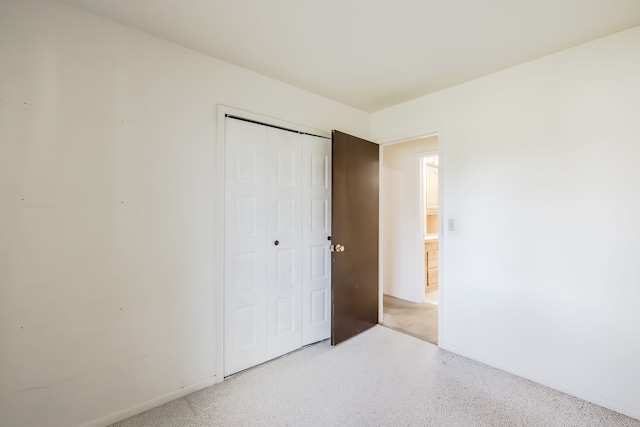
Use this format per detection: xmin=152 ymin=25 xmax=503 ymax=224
xmin=372 ymin=27 xmax=640 ymax=418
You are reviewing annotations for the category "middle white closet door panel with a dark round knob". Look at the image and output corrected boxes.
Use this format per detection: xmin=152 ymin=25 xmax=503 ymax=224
xmin=266 ymin=128 xmax=302 ymax=359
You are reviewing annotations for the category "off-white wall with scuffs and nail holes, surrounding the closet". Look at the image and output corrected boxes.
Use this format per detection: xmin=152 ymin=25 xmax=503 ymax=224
xmin=0 ymin=0 xmax=369 ymax=427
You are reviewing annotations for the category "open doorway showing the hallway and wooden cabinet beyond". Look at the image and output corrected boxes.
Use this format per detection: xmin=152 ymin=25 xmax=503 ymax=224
xmin=381 ymin=134 xmax=441 ymax=344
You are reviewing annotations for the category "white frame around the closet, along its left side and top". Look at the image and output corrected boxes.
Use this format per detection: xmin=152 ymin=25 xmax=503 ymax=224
xmin=218 ymin=104 xmax=331 ymax=383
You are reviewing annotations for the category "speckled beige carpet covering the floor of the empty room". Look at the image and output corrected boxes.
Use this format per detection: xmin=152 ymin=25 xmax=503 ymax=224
xmin=114 ymin=326 xmax=640 ymax=427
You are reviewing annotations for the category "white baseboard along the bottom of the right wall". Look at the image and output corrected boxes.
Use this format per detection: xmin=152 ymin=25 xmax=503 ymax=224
xmin=440 ymin=343 xmax=640 ymax=420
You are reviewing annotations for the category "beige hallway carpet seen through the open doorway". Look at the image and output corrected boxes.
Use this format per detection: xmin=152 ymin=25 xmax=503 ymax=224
xmin=382 ymin=295 xmax=438 ymax=344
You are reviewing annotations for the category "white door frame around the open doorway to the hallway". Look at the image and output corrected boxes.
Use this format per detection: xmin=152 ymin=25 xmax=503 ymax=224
xmin=373 ymin=124 xmax=450 ymax=347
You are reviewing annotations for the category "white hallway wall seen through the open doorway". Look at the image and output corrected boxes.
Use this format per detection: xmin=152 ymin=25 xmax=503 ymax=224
xmin=381 ymin=136 xmax=438 ymax=302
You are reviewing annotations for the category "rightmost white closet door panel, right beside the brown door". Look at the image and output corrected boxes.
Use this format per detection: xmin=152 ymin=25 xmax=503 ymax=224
xmin=302 ymin=135 xmax=331 ymax=345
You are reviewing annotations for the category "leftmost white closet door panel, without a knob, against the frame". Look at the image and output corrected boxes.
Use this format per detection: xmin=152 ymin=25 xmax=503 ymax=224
xmin=224 ymin=120 xmax=271 ymax=375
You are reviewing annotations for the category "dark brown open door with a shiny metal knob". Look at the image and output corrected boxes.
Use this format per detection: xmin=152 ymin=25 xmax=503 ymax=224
xmin=331 ymin=130 xmax=379 ymax=345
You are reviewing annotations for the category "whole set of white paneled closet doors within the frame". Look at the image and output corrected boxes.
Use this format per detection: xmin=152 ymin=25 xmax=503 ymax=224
xmin=224 ymin=117 xmax=331 ymax=376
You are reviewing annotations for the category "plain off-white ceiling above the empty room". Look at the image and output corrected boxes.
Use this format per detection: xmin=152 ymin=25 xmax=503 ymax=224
xmin=59 ymin=0 xmax=640 ymax=112
